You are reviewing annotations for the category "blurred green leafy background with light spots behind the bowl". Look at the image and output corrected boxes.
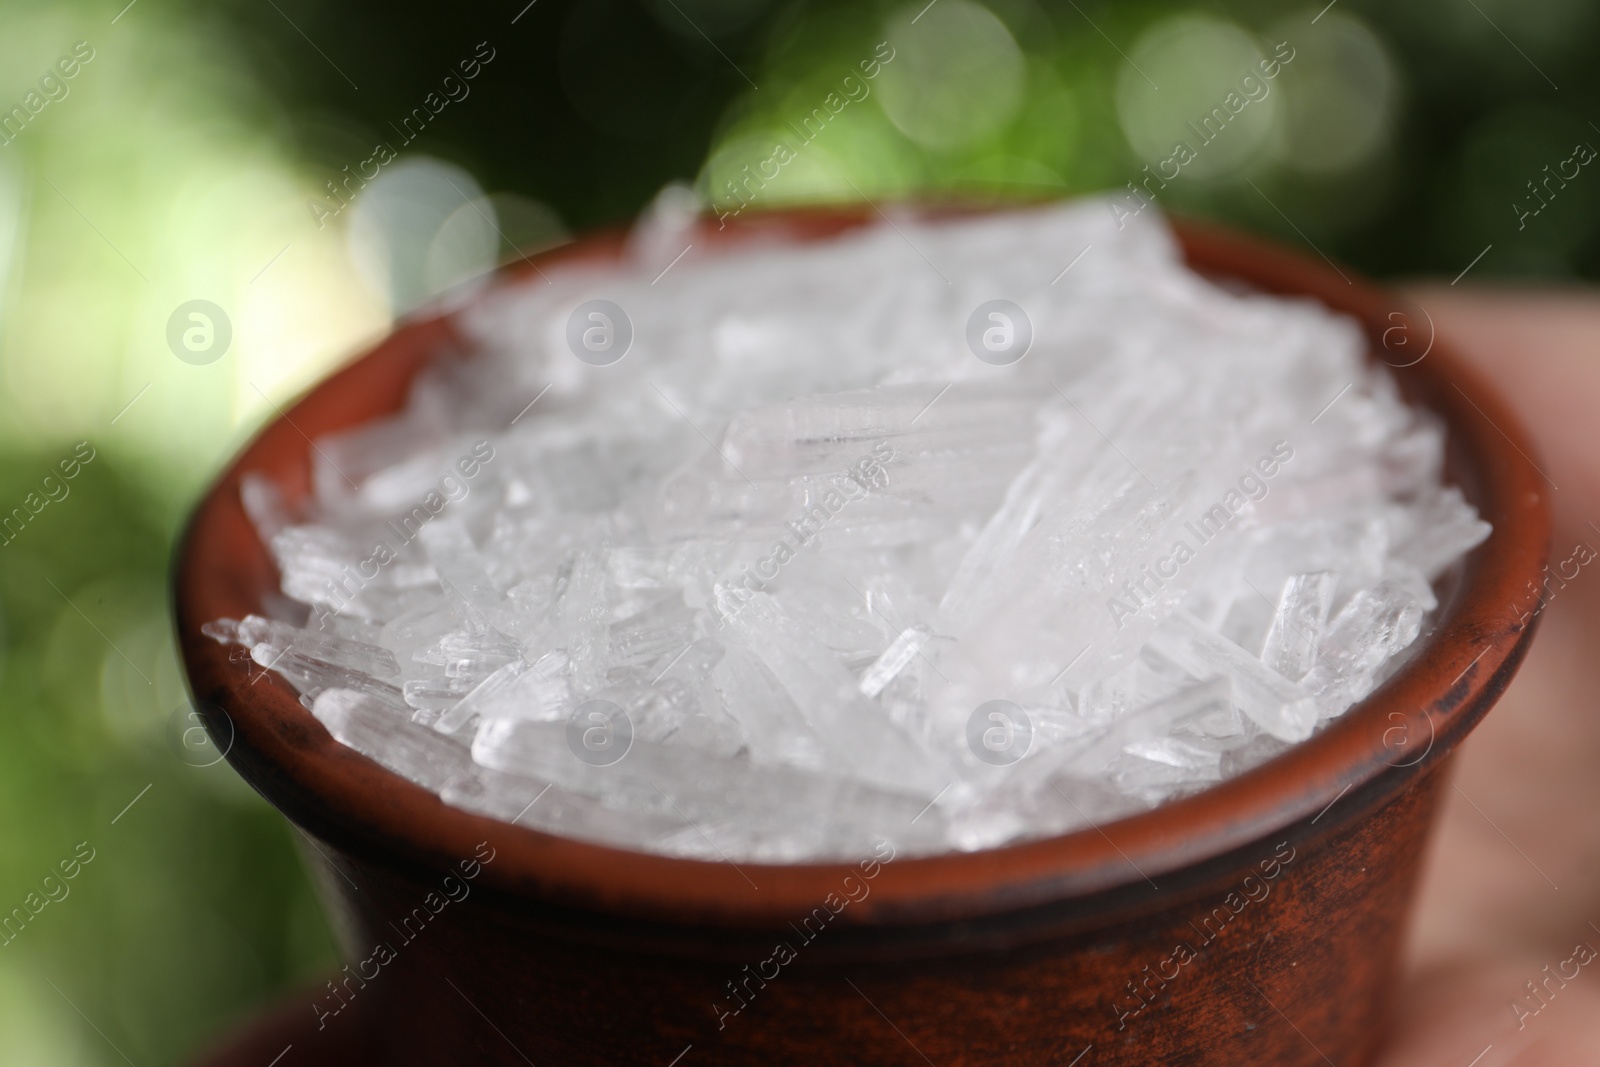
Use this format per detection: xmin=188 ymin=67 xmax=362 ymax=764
xmin=0 ymin=0 xmax=1600 ymax=1067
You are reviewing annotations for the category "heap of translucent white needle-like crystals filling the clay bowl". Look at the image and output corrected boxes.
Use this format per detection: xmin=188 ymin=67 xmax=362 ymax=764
xmin=208 ymin=200 xmax=1488 ymax=862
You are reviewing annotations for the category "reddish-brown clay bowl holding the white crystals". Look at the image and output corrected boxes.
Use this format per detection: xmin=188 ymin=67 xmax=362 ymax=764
xmin=176 ymin=204 xmax=1549 ymax=1067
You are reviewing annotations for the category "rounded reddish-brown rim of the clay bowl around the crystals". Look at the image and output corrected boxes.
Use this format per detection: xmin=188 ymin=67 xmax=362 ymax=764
xmin=173 ymin=202 xmax=1550 ymax=928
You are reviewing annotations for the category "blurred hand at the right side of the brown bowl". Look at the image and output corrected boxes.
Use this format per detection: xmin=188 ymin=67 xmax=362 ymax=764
xmin=1376 ymin=286 xmax=1600 ymax=1067
